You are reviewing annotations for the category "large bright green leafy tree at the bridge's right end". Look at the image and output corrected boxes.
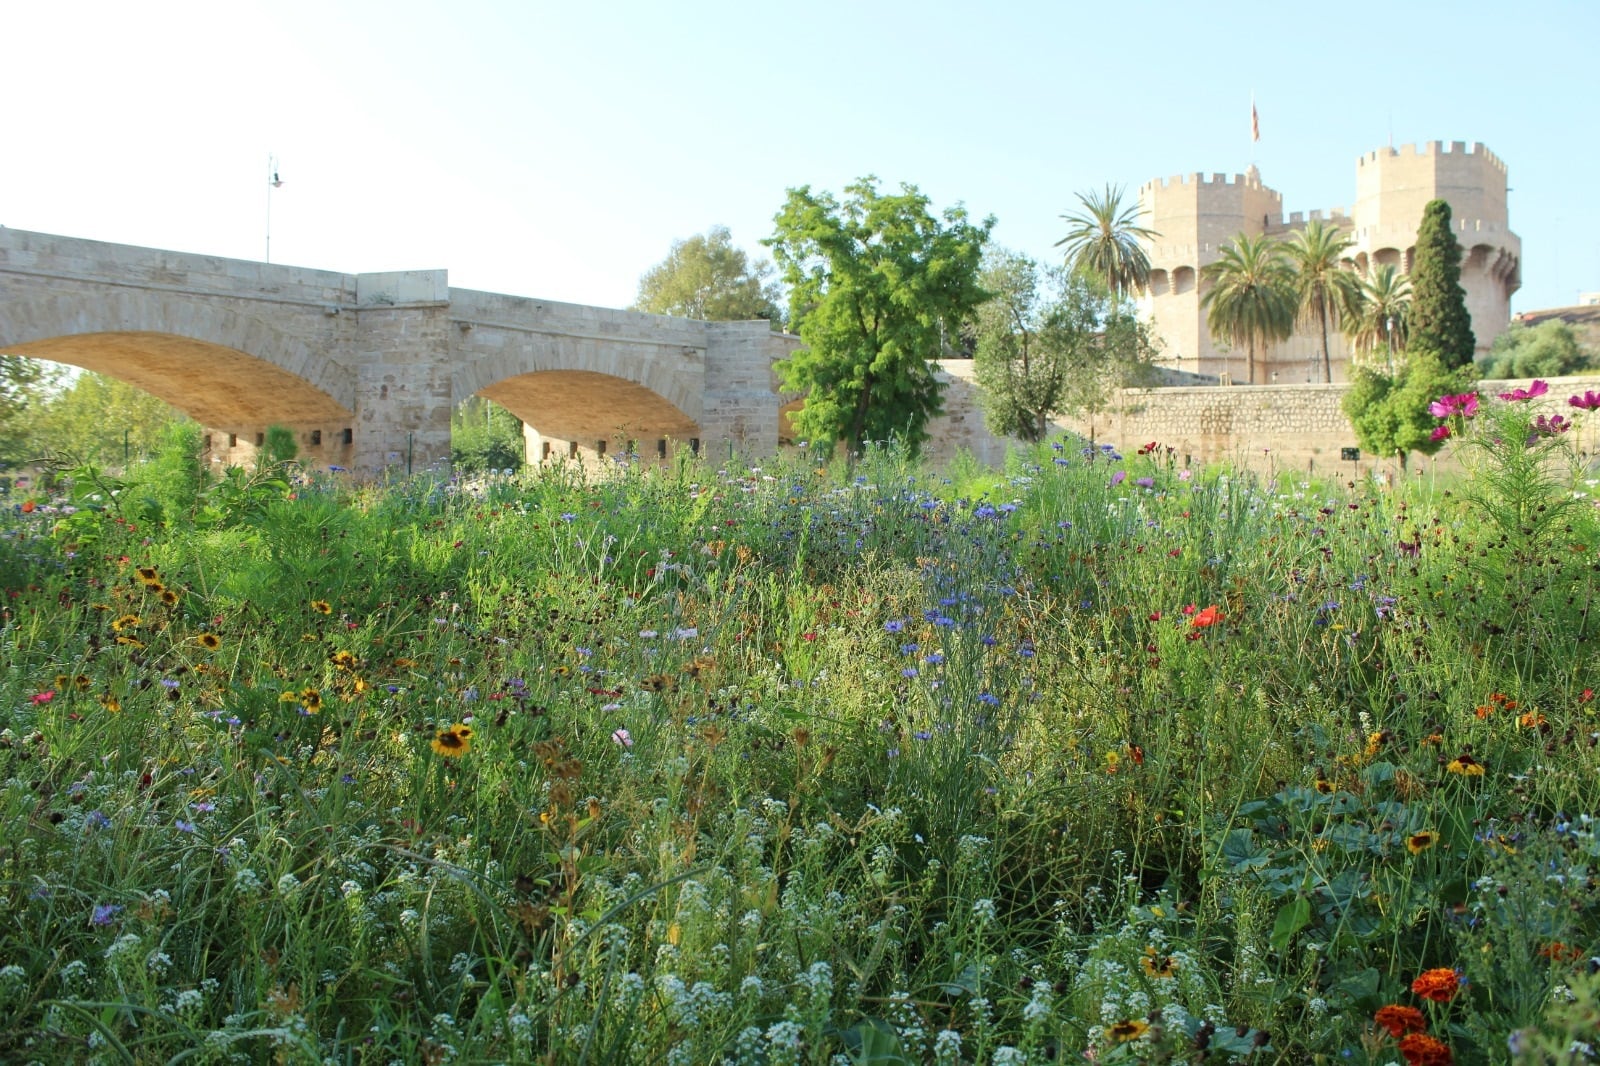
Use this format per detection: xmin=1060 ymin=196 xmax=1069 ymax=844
xmin=765 ymin=178 xmax=994 ymax=451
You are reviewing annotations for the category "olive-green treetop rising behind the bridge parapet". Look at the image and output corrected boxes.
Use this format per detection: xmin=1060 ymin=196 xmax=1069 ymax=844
xmin=634 ymin=226 xmax=782 ymax=325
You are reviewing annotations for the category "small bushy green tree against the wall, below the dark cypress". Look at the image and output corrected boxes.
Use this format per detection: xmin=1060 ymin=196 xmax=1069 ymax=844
xmin=1341 ymin=352 xmax=1472 ymax=467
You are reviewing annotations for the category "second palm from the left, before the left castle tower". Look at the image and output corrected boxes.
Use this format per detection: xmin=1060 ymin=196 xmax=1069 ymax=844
xmin=1200 ymin=234 xmax=1296 ymax=384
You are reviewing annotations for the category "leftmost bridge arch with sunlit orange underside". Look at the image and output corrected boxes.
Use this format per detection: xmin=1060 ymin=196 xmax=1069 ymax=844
xmin=0 ymin=288 xmax=357 ymax=427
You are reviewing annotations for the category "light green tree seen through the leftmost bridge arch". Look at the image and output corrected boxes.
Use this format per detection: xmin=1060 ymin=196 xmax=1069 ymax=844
xmin=27 ymin=371 xmax=186 ymax=471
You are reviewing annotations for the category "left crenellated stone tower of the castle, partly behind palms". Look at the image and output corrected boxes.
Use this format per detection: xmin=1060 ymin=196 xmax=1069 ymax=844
xmin=1139 ymin=166 xmax=1283 ymax=383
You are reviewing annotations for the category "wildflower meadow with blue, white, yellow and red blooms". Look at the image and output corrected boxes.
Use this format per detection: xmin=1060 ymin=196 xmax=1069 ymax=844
xmin=0 ymin=383 xmax=1600 ymax=1066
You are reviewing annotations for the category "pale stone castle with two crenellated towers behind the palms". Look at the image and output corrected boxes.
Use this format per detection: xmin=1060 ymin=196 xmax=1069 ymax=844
xmin=1139 ymin=141 xmax=1522 ymax=384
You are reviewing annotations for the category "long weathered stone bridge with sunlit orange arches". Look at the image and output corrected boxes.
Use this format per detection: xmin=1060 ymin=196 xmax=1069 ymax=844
xmin=0 ymin=229 xmax=798 ymax=474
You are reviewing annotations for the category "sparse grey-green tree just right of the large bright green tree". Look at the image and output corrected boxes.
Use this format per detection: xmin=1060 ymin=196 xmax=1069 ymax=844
xmin=966 ymin=250 xmax=1106 ymax=443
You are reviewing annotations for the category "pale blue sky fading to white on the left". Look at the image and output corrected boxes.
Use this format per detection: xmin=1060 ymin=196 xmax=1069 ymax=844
xmin=0 ymin=0 xmax=1600 ymax=311
